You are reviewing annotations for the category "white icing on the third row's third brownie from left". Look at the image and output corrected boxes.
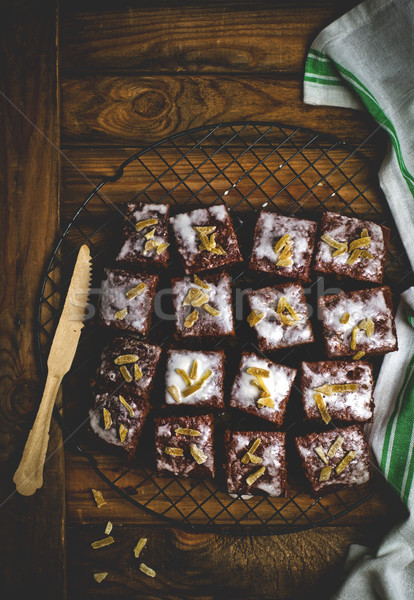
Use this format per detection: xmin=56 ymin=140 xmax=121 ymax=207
xmin=231 ymin=354 xmax=295 ymax=419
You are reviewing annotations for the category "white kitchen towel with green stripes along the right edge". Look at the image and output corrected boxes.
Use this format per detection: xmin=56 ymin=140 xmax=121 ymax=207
xmin=304 ymin=0 xmax=414 ymax=600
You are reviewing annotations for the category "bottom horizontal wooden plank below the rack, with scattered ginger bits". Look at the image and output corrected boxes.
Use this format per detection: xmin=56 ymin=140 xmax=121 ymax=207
xmin=68 ymin=519 xmax=396 ymax=600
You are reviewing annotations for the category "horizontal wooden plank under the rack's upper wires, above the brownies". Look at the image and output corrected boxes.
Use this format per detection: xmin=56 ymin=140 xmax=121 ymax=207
xmin=62 ymin=145 xmax=383 ymax=220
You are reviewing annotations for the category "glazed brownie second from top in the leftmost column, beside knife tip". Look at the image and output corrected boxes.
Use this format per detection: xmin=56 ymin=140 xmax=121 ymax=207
xmin=98 ymin=269 xmax=158 ymax=336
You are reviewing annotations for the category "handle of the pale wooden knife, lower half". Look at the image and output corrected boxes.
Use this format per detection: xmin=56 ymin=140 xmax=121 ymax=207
xmin=13 ymin=374 xmax=62 ymax=496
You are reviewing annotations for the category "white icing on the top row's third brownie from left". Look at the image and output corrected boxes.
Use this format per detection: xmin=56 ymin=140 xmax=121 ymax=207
xmin=253 ymin=212 xmax=314 ymax=272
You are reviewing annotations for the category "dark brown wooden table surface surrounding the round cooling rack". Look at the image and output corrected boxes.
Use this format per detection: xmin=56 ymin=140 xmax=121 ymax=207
xmin=0 ymin=0 xmax=402 ymax=600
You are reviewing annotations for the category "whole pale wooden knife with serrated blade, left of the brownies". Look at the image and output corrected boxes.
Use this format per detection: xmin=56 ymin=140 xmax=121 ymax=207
xmin=13 ymin=244 xmax=91 ymax=496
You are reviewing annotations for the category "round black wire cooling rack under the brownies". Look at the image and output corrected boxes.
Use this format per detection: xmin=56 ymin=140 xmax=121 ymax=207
xmin=37 ymin=123 xmax=413 ymax=534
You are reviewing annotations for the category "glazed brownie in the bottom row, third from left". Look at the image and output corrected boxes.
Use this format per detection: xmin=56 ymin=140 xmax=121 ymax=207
xmin=224 ymin=431 xmax=287 ymax=496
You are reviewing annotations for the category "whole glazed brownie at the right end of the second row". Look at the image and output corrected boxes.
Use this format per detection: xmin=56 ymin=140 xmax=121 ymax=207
xmin=318 ymin=286 xmax=398 ymax=358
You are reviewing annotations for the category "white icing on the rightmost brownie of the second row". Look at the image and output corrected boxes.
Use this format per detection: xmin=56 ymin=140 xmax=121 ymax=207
xmin=320 ymin=288 xmax=395 ymax=354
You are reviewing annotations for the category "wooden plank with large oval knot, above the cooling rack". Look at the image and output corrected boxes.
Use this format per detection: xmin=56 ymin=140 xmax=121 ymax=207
xmin=62 ymin=75 xmax=378 ymax=148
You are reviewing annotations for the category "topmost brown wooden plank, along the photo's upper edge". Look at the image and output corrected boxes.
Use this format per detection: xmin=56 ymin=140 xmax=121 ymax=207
xmin=62 ymin=0 xmax=357 ymax=73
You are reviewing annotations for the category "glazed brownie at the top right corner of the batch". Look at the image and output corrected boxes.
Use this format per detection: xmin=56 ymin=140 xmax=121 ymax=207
xmin=313 ymin=212 xmax=390 ymax=283
